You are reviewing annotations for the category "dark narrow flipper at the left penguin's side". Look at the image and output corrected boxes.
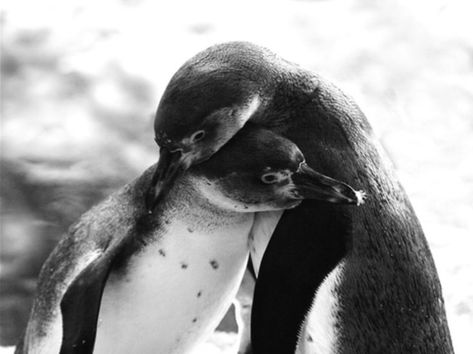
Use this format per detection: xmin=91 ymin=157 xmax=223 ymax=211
xmin=60 ymin=239 xmax=126 ymax=354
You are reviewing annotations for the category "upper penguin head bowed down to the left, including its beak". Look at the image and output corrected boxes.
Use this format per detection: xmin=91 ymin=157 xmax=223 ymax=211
xmin=147 ymin=42 xmax=272 ymax=210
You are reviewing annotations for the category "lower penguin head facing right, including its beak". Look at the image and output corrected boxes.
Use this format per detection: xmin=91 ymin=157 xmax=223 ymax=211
xmin=189 ymin=126 xmax=360 ymax=212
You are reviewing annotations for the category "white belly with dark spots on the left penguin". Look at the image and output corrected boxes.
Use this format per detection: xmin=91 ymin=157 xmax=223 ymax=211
xmin=94 ymin=214 xmax=253 ymax=354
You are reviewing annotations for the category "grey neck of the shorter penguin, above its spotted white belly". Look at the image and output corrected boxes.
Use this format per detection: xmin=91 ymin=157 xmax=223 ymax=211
xmin=115 ymin=165 xmax=254 ymax=269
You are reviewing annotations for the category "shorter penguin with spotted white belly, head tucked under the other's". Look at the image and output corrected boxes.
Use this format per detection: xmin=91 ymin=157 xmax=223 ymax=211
xmin=16 ymin=126 xmax=357 ymax=354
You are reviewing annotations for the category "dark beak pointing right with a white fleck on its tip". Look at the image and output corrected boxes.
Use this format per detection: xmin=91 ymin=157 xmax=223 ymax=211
xmin=292 ymin=163 xmax=365 ymax=205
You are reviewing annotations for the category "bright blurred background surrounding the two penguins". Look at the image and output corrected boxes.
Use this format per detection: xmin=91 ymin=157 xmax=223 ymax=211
xmin=0 ymin=0 xmax=473 ymax=354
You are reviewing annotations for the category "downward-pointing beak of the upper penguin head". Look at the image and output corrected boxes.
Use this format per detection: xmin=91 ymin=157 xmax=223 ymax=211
xmin=145 ymin=147 xmax=190 ymax=214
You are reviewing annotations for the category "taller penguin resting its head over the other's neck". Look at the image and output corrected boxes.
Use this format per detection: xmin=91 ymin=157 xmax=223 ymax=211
xmin=148 ymin=42 xmax=453 ymax=354
